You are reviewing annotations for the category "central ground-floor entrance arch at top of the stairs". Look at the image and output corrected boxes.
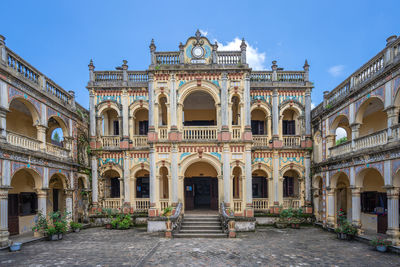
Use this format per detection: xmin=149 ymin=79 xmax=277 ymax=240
xmin=184 ymin=161 xmax=218 ymax=210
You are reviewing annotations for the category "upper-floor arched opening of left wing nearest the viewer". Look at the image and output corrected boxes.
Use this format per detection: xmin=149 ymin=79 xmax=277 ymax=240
xmin=6 ymin=98 xmax=39 ymax=139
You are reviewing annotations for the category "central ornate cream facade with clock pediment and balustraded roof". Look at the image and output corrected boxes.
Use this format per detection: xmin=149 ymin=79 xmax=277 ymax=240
xmin=87 ymin=32 xmax=313 ymax=220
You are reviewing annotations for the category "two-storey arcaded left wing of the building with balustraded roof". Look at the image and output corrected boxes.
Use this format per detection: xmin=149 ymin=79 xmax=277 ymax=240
xmin=0 ymin=35 xmax=90 ymax=246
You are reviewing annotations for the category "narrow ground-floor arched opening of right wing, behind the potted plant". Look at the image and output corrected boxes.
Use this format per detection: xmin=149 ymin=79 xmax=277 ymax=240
xmin=332 ymin=172 xmax=352 ymax=223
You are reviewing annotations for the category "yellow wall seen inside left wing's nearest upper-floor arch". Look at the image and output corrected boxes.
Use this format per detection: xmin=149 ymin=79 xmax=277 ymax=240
xmin=6 ymin=108 xmax=37 ymax=139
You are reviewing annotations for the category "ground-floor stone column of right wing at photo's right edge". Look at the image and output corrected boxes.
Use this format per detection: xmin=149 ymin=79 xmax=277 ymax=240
xmin=386 ymin=187 xmax=400 ymax=244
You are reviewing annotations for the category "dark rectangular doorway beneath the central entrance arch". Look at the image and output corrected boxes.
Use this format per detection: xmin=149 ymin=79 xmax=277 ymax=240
xmin=184 ymin=177 xmax=218 ymax=210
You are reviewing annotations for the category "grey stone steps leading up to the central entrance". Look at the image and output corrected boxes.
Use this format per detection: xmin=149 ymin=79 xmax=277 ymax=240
xmin=174 ymin=215 xmax=227 ymax=238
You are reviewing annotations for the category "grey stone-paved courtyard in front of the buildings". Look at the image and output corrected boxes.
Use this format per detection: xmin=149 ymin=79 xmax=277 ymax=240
xmin=0 ymin=227 xmax=400 ymax=266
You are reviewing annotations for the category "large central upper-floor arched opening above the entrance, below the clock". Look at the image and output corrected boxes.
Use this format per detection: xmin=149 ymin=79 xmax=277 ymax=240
xmin=183 ymin=91 xmax=217 ymax=126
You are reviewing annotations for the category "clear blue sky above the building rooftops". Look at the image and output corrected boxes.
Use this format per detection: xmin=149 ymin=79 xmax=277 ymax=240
xmin=0 ymin=0 xmax=400 ymax=107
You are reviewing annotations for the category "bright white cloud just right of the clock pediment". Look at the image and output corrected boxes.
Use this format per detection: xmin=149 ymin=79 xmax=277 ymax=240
xmin=217 ymin=37 xmax=266 ymax=70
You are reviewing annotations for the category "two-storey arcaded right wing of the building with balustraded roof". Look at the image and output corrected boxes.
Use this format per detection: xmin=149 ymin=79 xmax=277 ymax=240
xmin=312 ymin=36 xmax=400 ymax=243
